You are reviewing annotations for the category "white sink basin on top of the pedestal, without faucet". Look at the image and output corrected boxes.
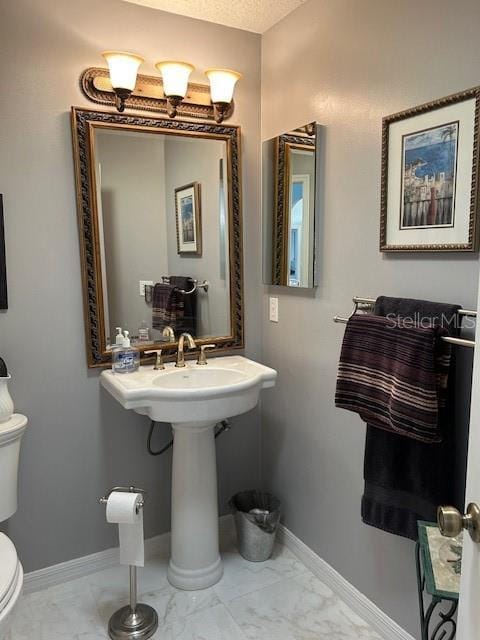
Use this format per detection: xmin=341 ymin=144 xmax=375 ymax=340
xmin=101 ymin=356 xmax=277 ymax=426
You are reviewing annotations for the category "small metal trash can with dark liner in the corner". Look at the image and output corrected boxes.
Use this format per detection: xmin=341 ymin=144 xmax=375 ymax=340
xmin=229 ymin=491 xmax=281 ymax=562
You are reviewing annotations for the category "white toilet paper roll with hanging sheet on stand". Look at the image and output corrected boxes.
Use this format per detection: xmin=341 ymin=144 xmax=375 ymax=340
xmin=107 ymin=491 xmax=145 ymax=567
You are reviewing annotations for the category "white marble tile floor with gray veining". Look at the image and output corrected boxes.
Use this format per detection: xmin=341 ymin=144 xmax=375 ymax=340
xmin=5 ymin=538 xmax=382 ymax=640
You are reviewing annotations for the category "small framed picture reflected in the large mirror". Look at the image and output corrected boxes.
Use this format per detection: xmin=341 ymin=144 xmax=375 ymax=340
xmin=175 ymin=182 xmax=202 ymax=256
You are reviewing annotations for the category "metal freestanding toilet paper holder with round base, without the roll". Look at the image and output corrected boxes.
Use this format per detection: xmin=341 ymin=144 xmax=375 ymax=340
xmin=98 ymin=486 xmax=158 ymax=640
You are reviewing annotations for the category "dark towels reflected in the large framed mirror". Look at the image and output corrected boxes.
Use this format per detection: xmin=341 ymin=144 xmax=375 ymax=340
xmin=152 ymin=276 xmax=197 ymax=336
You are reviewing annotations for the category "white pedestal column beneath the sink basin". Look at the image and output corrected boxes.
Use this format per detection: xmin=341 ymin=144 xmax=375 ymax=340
xmin=168 ymin=422 xmax=223 ymax=590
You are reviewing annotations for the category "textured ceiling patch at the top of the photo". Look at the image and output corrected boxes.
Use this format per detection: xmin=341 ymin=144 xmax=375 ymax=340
xmin=124 ymin=0 xmax=306 ymax=33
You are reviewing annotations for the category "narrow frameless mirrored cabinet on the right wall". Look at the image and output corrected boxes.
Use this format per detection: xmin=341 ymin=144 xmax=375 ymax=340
xmin=262 ymin=123 xmax=319 ymax=288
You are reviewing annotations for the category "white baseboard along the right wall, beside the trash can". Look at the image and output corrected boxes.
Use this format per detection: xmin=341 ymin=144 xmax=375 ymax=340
xmin=278 ymin=525 xmax=414 ymax=640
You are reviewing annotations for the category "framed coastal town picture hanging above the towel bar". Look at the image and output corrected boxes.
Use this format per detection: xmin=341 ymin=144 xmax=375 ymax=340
xmin=380 ymin=87 xmax=480 ymax=252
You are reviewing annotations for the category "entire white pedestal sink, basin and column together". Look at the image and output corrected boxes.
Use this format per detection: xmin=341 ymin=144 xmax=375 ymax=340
xmin=101 ymin=356 xmax=277 ymax=590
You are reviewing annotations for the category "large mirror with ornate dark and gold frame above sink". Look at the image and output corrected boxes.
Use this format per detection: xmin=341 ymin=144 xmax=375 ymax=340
xmin=72 ymin=107 xmax=244 ymax=367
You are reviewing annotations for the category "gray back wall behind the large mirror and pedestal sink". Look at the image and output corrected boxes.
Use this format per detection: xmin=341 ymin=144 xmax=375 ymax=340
xmin=0 ymin=0 xmax=260 ymax=571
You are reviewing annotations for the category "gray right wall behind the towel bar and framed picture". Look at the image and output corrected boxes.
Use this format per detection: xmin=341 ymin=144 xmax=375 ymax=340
xmin=262 ymin=0 xmax=480 ymax=636
